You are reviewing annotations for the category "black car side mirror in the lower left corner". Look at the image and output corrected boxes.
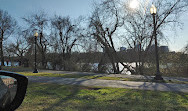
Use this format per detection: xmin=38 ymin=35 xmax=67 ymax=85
xmin=0 ymin=71 xmax=28 ymax=111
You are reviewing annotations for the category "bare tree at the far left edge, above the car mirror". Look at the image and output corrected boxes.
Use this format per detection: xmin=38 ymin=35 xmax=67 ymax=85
xmin=0 ymin=9 xmax=16 ymax=66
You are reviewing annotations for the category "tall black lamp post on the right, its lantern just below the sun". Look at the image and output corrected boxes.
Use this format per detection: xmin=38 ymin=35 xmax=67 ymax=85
xmin=150 ymin=5 xmax=163 ymax=80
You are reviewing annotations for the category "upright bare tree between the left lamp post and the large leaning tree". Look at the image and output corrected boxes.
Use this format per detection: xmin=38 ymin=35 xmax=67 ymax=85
xmin=51 ymin=15 xmax=83 ymax=70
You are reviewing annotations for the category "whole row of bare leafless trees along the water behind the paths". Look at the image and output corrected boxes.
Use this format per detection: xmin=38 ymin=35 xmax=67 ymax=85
xmin=0 ymin=0 xmax=188 ymax=74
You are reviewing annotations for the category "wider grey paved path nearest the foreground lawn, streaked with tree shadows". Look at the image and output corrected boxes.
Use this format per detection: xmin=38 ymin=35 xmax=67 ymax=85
xmin=28 ymin=76 xmax=188 ymax=93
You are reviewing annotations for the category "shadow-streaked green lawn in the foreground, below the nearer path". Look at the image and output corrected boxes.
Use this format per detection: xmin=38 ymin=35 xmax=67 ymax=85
xmin=16 ymin=83 xmax=188 ymax=111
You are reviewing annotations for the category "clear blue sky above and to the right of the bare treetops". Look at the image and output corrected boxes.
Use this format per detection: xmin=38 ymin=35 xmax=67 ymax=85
xmin=0 ymin=0 xmax=188 ymax=51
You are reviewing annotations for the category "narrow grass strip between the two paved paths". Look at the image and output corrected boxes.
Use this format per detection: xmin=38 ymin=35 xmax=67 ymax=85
xmin=17 ymin=72 xmax=188 ymax=84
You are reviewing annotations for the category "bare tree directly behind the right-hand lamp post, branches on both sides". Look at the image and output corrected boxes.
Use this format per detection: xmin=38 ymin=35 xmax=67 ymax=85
xmin=124 ymin=0 xmax=188 ymax=74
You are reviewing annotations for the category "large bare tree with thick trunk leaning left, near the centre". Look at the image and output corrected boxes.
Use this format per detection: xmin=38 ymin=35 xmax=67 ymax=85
xmin=89 ymin=0 xmax=134 ymax=73
